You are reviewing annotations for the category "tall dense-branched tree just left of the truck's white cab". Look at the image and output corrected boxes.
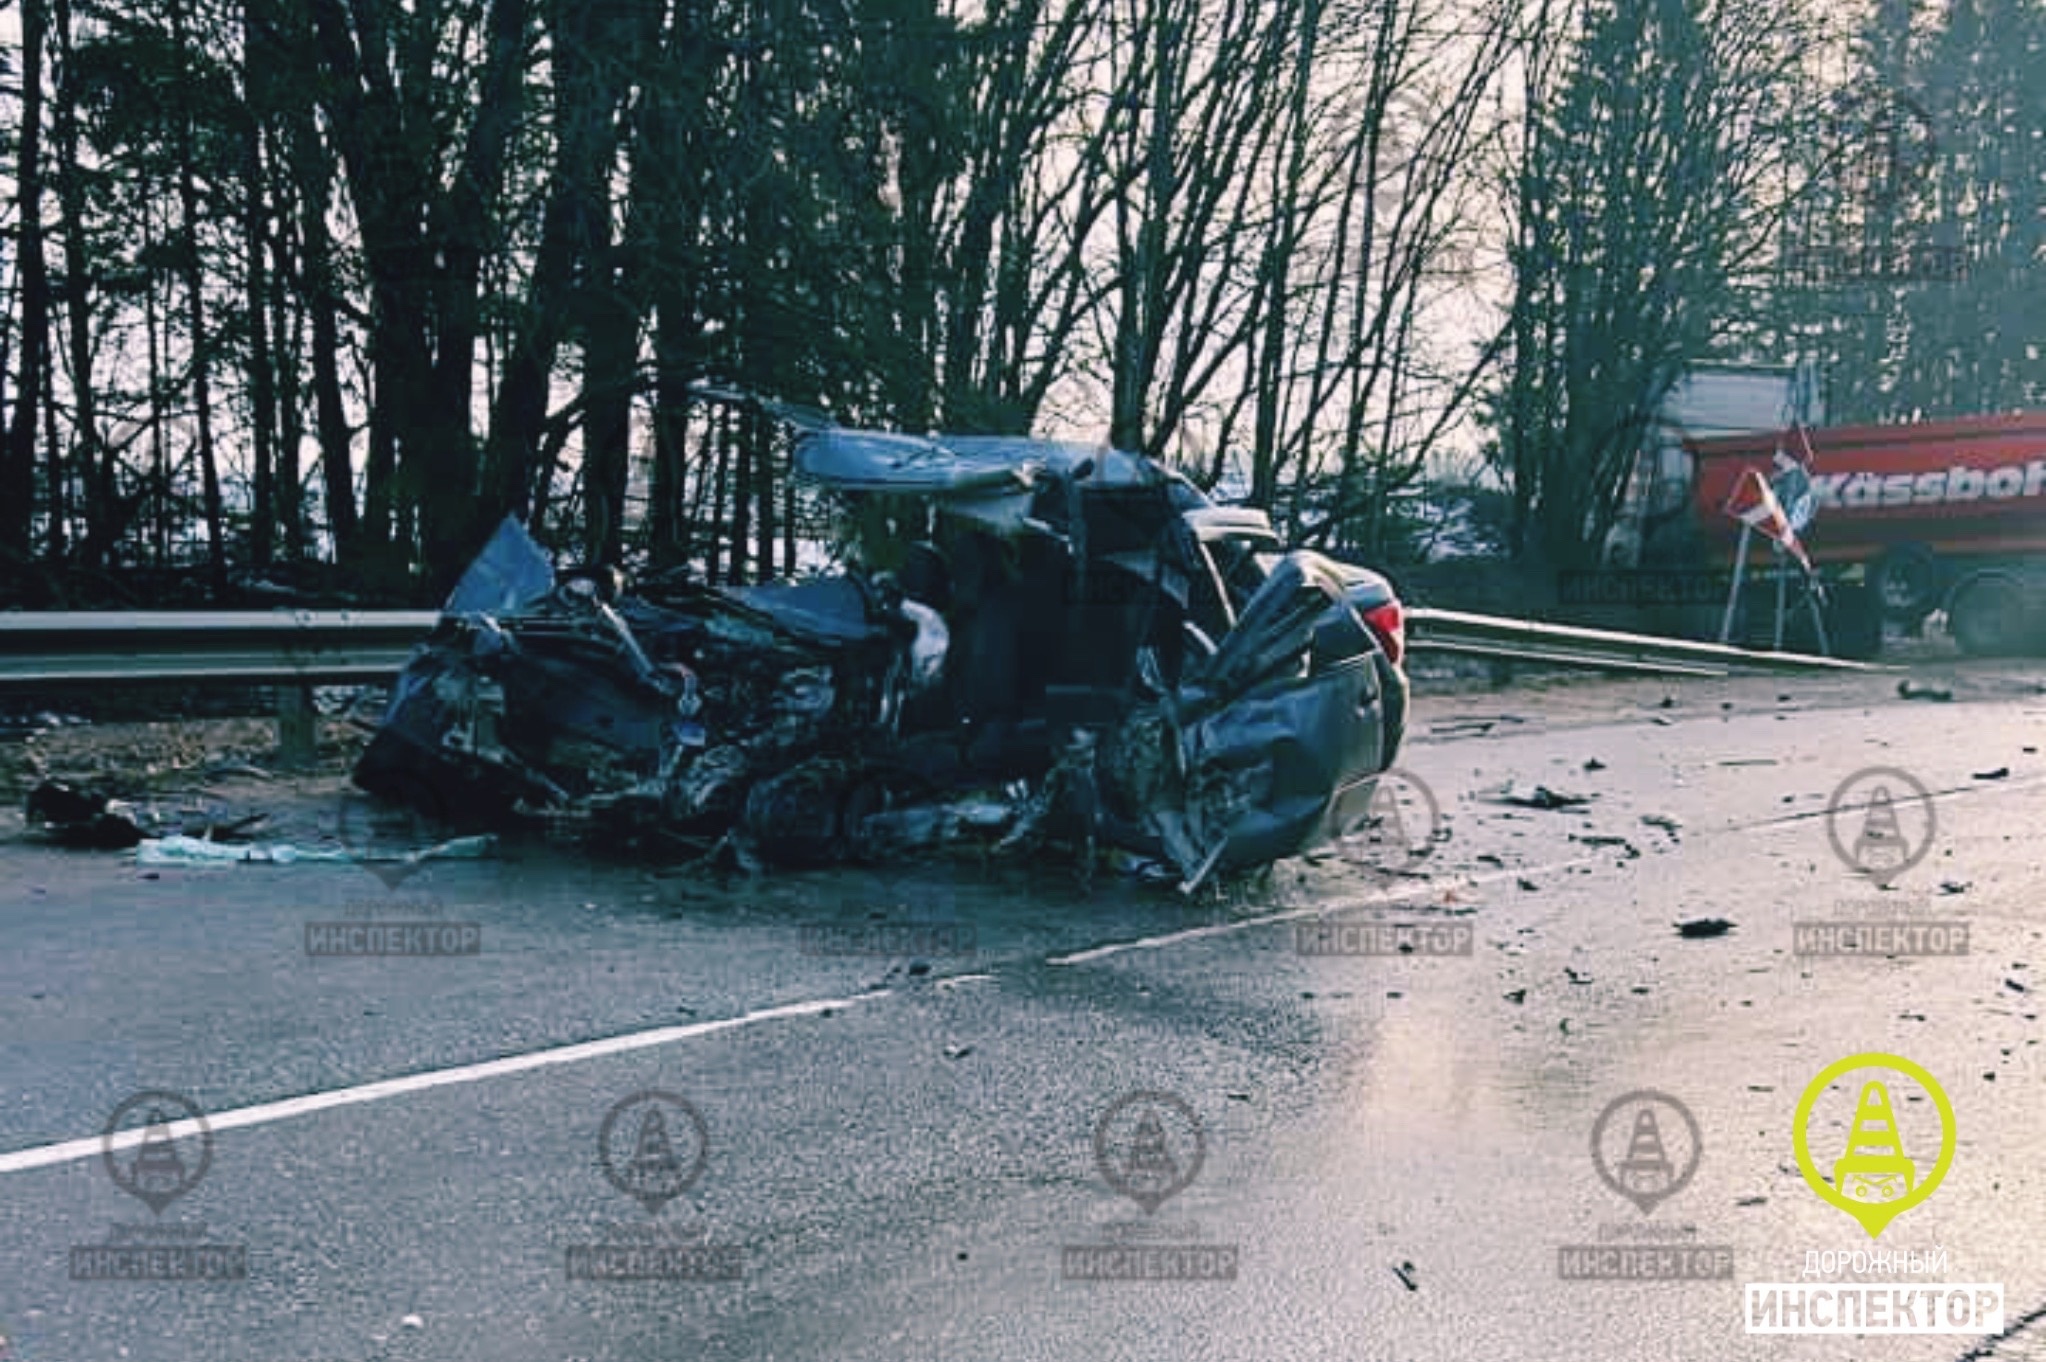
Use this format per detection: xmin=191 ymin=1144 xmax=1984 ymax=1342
xmin=1498 ymin=0 xmax=1800 ymax=566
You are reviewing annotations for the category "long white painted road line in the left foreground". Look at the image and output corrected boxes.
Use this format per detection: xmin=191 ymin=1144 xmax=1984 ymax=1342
xmin=0 ymin=990 xmax=890 ymax=1174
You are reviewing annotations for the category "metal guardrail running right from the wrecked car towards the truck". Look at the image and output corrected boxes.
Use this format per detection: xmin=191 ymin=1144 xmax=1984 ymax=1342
xmin=1406 ymin=609 xmax=1886 ymax=677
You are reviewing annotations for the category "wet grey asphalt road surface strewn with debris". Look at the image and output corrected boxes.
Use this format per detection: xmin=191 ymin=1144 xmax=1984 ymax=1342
xmin=0 ymin=681 xmax=2046 ymax=1362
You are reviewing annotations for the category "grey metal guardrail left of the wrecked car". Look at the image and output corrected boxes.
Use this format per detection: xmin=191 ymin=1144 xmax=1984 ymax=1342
xmin=0 ymin=609 xmax=440 ymax=685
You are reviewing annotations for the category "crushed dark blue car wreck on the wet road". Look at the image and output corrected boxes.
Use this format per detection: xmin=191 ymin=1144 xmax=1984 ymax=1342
xmin=354 ymin=427 xmax=1408 ymax=890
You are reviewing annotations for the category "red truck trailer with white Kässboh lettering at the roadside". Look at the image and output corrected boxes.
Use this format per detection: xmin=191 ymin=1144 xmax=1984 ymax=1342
xmin=1684 ymin=411 xmax=2046 ymax=654
